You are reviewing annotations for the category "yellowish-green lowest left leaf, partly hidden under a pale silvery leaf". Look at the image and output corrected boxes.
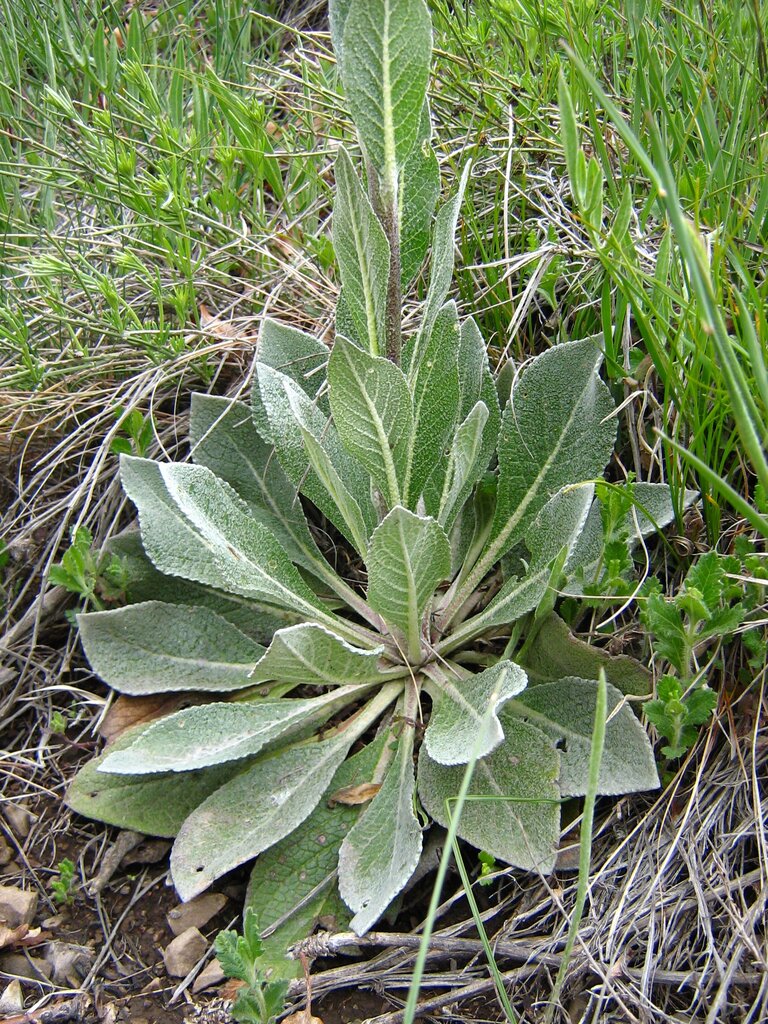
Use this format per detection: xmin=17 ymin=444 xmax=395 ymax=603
xmin=65 ymin=726 xmax=238 ymax=838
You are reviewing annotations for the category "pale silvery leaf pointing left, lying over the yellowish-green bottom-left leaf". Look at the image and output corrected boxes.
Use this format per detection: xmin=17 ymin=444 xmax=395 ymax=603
xmin=100 ymin=687 xmax=362 ymax=775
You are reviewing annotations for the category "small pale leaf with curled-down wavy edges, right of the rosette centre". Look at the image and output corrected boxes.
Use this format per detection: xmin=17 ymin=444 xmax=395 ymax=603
xmin=424 ymin=662 xmax=527 ymax=765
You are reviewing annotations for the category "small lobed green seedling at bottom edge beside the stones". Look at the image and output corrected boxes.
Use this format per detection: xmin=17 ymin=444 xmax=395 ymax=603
xmin=215 ymin=906 xmax=288 ymax=1024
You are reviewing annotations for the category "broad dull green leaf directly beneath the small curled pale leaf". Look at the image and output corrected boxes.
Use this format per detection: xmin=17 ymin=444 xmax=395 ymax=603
xmin=418 ymin=710 xmax=560 ymax=873
